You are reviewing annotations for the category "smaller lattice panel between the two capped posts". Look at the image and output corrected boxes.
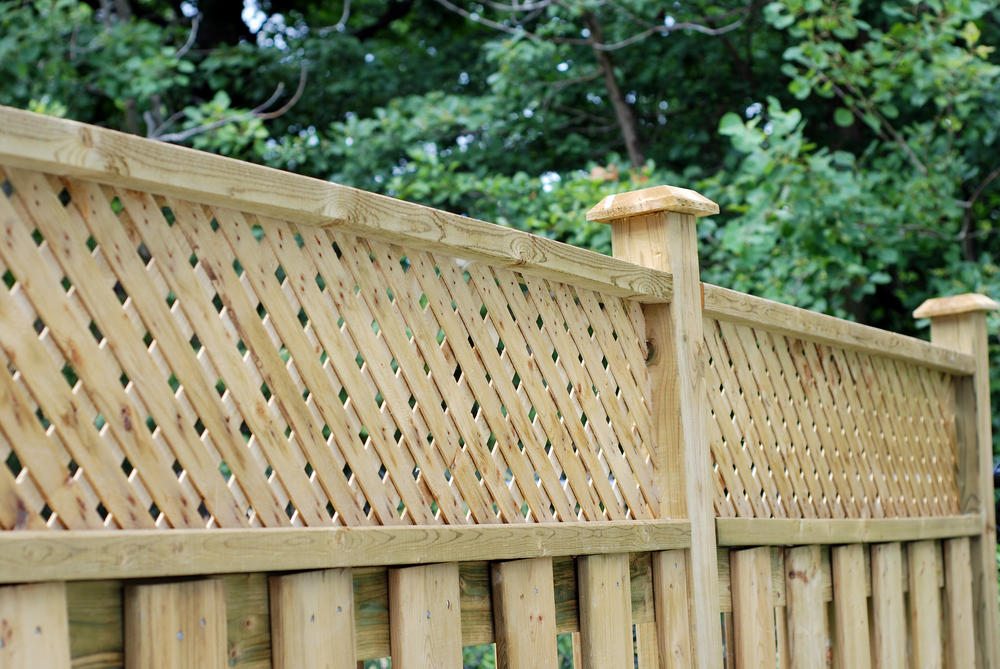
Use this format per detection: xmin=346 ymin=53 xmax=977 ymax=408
xmin=705 ymin=319 xmax=959 ymax=518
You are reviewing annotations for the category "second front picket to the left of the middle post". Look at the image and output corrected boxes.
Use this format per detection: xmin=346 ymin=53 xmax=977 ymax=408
xmin=576 ymin=554 xmax=634 ymax=668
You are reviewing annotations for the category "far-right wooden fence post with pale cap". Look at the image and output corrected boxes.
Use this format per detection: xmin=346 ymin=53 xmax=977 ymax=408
xmin=913 ymin=293 xmax=1000 ymax=669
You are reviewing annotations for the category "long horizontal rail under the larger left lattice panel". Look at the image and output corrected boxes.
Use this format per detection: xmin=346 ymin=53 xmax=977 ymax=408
xmin=0 ymin=520 xmax=691 ymax=583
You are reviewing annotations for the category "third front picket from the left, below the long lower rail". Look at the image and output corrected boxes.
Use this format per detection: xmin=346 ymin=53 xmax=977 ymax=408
xmin=269 ymin=569 xmax=357 ymax=669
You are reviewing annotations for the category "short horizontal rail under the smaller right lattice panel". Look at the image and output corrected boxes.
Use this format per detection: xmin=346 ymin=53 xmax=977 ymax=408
xmin=715 ymin=514 xmax=984 ymax=546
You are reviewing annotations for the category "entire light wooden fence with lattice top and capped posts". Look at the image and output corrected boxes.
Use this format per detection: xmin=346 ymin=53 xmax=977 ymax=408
xmin=0 ymin=108 xmax=1000 ymax=669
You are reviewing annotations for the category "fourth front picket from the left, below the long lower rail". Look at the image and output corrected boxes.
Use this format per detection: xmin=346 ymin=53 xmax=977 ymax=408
xmin=389 ymin=563 xmax=462 ymax=669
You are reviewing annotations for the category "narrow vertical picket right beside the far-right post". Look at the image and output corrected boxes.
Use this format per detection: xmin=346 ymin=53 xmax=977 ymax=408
xmin=942 ymin=537 xmax=976 ymax=667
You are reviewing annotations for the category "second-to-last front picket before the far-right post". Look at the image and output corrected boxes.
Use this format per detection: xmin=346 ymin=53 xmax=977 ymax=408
xmin=907 ymin=541 xmax=942 ymax=669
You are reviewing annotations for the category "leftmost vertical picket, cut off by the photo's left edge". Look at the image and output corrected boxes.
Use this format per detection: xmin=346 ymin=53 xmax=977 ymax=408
xmin=0 ymin=583 xmax=70 ymax=669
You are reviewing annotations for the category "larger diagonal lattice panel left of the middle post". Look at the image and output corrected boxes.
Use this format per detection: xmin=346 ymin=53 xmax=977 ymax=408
xmin=0 ymin=169 xmax=658 ymax=529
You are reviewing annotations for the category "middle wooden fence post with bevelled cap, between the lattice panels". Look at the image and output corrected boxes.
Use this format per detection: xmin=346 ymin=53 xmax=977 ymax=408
xmin=587 ymin=186 xmax=722 ymax=669
